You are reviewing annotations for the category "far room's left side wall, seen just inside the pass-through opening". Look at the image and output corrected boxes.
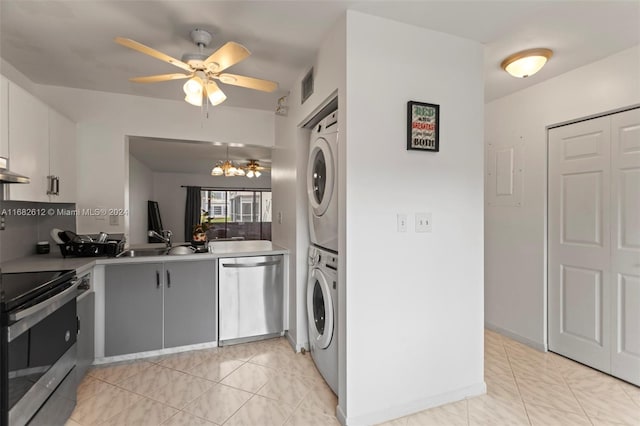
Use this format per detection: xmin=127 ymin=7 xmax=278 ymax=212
xmin=129 ymin=155 xmax=154 ymax=244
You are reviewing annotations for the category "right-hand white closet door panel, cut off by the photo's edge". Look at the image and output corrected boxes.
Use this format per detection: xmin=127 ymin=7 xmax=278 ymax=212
xmin=611 ymin=109 xmax=640 ymax=385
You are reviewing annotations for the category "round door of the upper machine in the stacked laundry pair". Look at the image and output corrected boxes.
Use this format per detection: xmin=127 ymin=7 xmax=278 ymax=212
xmin=307 ymin=137 xmax=336 ymax=216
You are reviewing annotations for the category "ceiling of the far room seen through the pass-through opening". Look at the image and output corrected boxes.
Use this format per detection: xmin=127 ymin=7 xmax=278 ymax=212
xmin=129 ymin=136 xmax=271 ymax=175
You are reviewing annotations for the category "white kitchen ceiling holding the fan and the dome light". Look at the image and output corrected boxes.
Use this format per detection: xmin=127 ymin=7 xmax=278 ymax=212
xmin=0 ymin=0 xmax=640 ymax=110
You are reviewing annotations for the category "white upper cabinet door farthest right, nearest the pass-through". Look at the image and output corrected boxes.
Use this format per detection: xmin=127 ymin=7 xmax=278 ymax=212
xmin=49 ymin=108 xmax=77 ymax=203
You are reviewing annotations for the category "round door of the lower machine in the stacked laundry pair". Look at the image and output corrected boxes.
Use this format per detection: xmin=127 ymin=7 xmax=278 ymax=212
xmin=307 ymin=268 xmax=334 ymax=349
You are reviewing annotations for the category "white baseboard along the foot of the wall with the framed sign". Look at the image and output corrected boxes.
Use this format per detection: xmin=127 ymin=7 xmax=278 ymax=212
xmin=336 ymin=382 xmax=487 ymax=426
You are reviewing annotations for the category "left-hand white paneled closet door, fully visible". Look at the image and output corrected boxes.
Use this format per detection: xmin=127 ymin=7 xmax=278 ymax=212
xmin=548 ymin=117 xmax=611 ymax=372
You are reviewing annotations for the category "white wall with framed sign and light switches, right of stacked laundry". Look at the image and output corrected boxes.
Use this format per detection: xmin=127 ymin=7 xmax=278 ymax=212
xmin=341 ymin=11 xmax=485 ymax=425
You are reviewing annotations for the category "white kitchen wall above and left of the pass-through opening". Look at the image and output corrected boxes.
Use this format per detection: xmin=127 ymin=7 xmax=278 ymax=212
xmin=28 ymin=85 xmax=274 ymax=238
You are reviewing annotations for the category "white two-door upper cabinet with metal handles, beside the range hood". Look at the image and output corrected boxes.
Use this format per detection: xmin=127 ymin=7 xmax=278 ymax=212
xmin=3 ymin=81 xmax=77 ymax=203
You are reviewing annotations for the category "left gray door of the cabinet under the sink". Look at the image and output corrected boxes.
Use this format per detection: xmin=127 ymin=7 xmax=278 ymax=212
xmin=104 ymin=263 xmax=163 ymax=356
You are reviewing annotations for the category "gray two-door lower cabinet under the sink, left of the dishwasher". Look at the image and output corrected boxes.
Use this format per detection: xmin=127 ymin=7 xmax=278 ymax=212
xmin=105 ymin=260 xmax=217 ymax=356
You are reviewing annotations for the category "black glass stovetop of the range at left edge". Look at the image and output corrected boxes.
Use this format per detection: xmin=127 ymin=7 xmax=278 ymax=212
xmin=0 ymin=269 xmax=75 ymax=312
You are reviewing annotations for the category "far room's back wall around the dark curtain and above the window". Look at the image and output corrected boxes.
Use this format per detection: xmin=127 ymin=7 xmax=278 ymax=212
xmin=154 ymin=172 xmax=271 ymax=242
